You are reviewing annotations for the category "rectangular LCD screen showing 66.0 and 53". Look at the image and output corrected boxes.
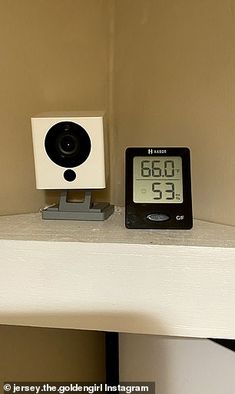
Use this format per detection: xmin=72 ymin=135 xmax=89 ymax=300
xmin=133 ymin=156 xmax=183 ymax=204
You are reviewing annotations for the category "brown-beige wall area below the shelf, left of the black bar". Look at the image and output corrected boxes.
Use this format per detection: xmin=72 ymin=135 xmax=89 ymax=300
xmin=0 ymin=326 xmax=105 ymax=382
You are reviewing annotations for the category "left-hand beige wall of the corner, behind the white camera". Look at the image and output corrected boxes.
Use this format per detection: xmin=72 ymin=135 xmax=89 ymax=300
xmin=0 ymin=0 xmax=110 ymax=214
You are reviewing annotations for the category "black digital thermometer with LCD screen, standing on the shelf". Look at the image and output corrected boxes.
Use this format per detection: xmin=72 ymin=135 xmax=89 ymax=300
xmin=125 ymin=147 xmax=193 ymax=230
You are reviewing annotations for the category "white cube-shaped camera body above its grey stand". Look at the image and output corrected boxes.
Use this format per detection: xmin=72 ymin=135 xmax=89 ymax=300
xmin=31 ymin=112 xmax=105 ymax=189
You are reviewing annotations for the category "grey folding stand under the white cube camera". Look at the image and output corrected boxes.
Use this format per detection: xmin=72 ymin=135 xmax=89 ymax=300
xmin=42 ymin=190 xmax=114 ymax=221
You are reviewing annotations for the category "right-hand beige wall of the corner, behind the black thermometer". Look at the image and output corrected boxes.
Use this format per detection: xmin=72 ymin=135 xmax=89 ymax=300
xmin=112 ymin=0 xmax=235 ymax=224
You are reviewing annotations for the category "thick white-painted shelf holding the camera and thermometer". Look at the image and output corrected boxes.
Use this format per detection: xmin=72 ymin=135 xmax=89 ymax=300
xmin=0 ymin=209 xmax=235 ymax=339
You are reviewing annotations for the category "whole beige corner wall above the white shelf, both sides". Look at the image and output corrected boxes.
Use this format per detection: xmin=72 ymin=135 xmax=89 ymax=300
xmin=0 ymin=0 xmax=235 ymax=224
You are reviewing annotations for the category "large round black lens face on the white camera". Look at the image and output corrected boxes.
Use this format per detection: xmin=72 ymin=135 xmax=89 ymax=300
xmin=44 ymin=121 xmax=91 ymax=168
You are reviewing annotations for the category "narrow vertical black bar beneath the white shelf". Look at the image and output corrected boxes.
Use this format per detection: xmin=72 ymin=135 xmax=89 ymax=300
xmin=105 ymin=332 xmax=119 ymax=386
